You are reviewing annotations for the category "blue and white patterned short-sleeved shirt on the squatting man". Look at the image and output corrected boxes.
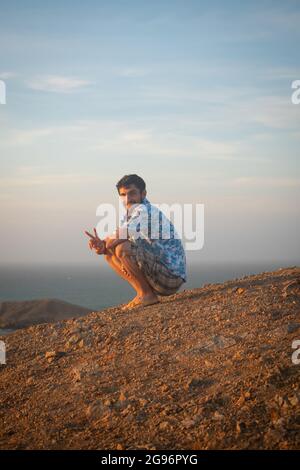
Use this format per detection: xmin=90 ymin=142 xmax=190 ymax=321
xmin=119 ymin=198 xmax=187 ymax=282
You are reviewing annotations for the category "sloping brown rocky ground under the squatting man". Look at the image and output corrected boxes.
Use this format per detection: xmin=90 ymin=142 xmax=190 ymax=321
xmin=0 ymin=267 xmax=300 ymax=450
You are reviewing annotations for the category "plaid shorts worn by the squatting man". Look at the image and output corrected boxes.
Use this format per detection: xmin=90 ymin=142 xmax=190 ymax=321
xmin=131 ymin=242 xmax=185 ymax=296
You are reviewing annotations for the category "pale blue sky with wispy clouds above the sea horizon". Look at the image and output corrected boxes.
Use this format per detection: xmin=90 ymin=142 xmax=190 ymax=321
xmin=0 ymin=0 xmax=300 ymax=265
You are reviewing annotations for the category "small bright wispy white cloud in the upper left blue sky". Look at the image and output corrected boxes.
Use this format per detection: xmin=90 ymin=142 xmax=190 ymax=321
xmin=28 ymin=75 xmax=92 ymax=93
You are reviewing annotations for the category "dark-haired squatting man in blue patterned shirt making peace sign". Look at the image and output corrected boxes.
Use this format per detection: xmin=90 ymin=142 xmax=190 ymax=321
xmin=86 ymin=174 xmax=187 ymax=310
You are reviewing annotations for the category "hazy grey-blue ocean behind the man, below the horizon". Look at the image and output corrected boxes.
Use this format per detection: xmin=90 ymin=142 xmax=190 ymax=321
xmin=0 ymin=262 xmax=297 ymax=334
